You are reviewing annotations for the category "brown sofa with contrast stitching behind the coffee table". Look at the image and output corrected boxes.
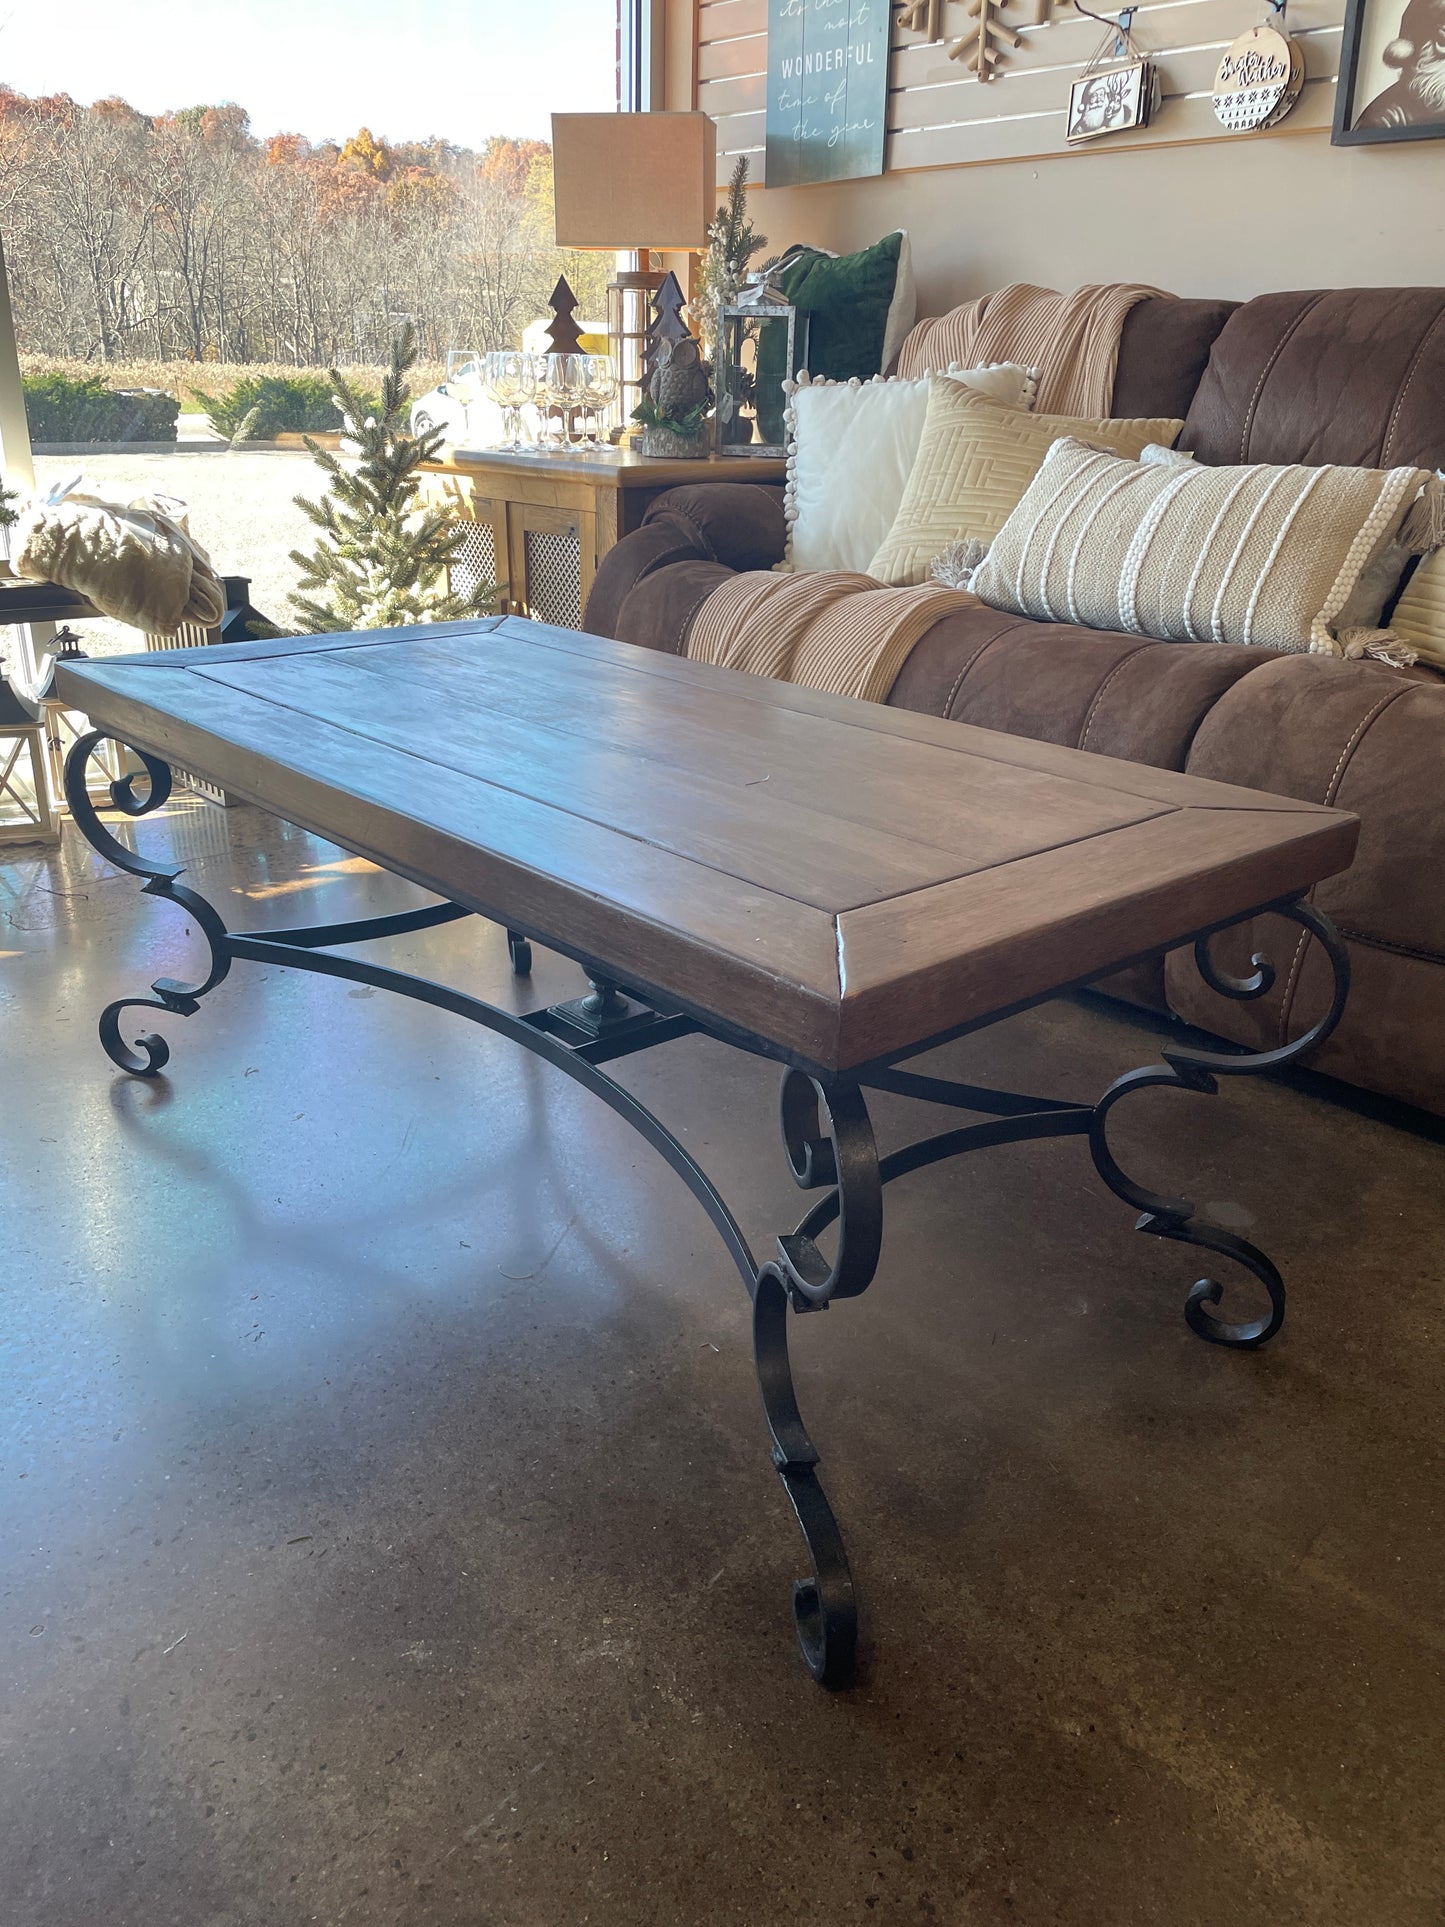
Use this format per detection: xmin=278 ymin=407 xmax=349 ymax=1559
xmin=586 ymin=289 xmax=1445 ymax=1112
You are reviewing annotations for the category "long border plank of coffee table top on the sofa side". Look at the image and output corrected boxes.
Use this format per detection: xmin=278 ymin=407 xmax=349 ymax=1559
xmin=483 ymin=615 xmax=1331 ymax=815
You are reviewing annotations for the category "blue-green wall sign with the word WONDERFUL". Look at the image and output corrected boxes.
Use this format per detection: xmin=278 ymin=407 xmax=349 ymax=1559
xmin=765 ymin=0 xmax=888 ymax=187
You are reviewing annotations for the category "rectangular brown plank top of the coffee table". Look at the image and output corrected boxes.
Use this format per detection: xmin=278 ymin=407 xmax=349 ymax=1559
xmin=58 ymin=617 xmax=1358 ymax=1071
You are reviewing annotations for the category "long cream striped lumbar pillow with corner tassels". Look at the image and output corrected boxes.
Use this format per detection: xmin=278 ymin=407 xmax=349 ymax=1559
xmin=969 ymin=439 xmax=1432 ymax=655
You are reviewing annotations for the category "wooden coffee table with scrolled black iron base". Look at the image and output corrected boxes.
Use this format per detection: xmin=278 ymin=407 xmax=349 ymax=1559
xmin=60 ymin=617 xmax=1358 ymax=1686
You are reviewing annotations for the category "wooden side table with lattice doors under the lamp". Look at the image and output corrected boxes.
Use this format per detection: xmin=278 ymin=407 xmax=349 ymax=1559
xmin=422 ymin=449 xmax=786 ymax=628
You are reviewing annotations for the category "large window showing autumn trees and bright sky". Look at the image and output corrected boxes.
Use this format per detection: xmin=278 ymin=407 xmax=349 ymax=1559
xmin=0 ymin=0 xmax=628 ymax=653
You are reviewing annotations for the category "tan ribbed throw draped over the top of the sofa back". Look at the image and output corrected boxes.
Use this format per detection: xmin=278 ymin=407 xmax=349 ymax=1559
xmin=898 ymin=281 xmax=1173 ymax=420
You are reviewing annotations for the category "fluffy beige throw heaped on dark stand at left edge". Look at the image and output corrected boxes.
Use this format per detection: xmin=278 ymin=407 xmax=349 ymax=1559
xmin=10 ymin=495 xmax=225 ymax=636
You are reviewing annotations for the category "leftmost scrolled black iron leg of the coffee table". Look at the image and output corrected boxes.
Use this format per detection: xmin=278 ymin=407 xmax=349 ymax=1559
xmin=66 ymin=730 xmax=231 ymax=1077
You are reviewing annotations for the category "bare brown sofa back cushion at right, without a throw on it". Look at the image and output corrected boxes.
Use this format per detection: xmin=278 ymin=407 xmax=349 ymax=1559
xmin=1179 ymin=287 xmax=1445 ymax=468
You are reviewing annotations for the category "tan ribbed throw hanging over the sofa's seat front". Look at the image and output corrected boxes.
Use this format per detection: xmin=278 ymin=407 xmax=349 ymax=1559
xmin=688 ymin=570 xmax=979 ymax=703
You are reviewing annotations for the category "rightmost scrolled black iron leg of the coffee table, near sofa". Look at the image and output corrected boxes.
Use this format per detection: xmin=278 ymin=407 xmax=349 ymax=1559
xmin=1089 ymin=902 xmax=1351 ymax=1349
